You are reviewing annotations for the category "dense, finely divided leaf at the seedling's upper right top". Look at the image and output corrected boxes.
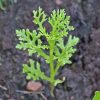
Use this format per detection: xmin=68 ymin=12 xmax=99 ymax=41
xmin=48 ymin=9 xmax=74 ymax=40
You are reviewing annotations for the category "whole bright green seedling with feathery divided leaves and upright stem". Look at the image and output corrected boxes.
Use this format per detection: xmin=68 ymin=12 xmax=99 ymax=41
xmin=16 ymin=7 xmax=79 ymax=93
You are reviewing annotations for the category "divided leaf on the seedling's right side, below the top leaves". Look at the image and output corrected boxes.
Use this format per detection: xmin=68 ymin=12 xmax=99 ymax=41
xmin=54 ymin=35 xmax=79 ymax=66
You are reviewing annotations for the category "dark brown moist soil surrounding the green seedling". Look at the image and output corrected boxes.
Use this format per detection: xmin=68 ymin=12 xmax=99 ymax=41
xmin=0 ymin=0 xmax=100 ymax=100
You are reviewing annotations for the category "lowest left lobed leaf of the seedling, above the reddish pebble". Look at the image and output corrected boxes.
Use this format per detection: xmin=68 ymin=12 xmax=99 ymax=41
xmin=23 ymin=59 xmax=48 ymax=80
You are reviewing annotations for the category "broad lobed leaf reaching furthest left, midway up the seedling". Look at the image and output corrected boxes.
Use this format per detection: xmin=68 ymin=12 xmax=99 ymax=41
xmin=16 ymin=29 xmax=49 ymax=60
